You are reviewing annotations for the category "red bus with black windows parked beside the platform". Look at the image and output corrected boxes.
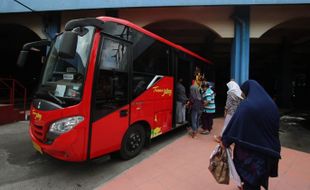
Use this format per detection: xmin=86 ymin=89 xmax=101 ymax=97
xmin=19 ymin=17 xmax=210 ymax=162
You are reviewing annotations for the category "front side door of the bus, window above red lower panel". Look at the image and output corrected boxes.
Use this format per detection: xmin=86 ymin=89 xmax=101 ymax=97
xmin=89 ymin=37 xmax=131 ymax=158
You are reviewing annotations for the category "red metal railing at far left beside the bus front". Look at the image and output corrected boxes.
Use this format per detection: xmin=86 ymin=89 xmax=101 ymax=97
xmin=0 ymin=78 xmax=27 ymax=114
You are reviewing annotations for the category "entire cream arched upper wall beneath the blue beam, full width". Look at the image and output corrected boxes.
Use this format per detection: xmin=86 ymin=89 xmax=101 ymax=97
xmin=0 ymin=5 xmax=310 ymax=39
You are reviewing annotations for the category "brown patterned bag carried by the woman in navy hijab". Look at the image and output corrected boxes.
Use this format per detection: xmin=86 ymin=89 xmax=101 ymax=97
xmin=208 ymin=145 xmax=229 ymax=184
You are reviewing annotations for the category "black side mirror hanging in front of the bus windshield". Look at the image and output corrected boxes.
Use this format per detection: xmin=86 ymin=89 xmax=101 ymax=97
xmin=58 ymin=31 xmax=78 ymax=59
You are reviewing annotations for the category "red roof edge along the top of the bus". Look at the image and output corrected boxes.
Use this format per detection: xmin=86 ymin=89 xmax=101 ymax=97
xmin=97 ymin=16 xmax=212 ymax=63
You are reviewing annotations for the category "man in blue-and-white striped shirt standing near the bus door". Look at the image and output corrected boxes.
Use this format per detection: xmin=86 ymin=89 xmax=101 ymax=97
xmin=201 ymin=82 xmax=215 ymax=135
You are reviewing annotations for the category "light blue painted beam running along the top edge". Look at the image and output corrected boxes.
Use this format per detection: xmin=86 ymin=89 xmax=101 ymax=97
xmin=0 ymin=0 xmax=310 ymax=13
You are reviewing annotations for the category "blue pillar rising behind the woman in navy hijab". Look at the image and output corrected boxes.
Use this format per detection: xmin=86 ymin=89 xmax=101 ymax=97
xmin=230 ymin=6 xmax=250 ymax=84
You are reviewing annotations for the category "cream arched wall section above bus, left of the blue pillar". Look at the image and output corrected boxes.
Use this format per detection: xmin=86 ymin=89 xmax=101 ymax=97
xmin=119 ymin=7 xmax=234 ymax=38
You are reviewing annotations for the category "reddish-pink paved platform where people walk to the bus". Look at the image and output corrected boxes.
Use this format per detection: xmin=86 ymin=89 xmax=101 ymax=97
xmin=97 ymin=119 xmax=310 ymax=190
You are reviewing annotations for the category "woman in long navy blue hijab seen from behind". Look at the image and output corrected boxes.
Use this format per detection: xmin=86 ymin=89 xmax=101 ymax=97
xmin=221 ymin=80 xmax=281 ymax=190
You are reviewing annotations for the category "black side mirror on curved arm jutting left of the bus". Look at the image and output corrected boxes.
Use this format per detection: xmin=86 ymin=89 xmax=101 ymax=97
xmin=17 ymin=40 xmax=51 ymax=67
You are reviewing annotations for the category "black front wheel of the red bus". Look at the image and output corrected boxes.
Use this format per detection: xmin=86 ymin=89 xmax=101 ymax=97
xmin=120 ymin=124 xmax=146 ymax=160
